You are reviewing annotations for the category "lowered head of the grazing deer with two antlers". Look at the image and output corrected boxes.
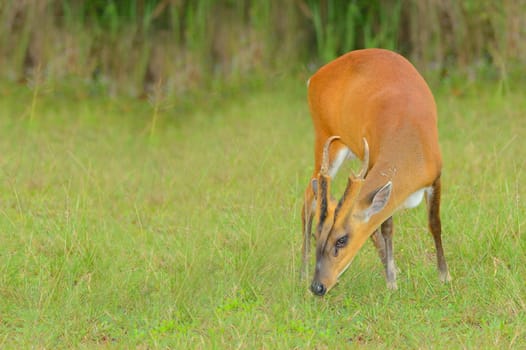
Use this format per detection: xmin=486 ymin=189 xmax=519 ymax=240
xmin=311 ymin=136 xmax=392 ymax=296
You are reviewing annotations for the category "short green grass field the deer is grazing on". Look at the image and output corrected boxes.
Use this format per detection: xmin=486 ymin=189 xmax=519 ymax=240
xmin=0 ymin=80 xmax=526 ymax=349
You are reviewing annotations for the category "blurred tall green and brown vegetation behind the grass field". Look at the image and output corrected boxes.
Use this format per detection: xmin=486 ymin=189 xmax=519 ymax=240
xmin=0 ymin=0 xmax=526 ymax=97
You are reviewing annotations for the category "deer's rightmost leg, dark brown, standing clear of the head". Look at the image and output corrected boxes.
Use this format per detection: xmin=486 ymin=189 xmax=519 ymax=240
xmin=426 ymin=177 xmax=451 ymax=282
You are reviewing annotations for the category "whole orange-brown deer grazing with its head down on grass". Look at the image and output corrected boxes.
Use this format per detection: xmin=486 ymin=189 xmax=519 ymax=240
xmin=301 ymin=49 xmax=451 ymax=296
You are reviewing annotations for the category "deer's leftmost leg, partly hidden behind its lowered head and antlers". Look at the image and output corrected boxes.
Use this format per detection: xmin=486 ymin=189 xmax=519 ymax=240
xmin=300 ymin=136 xmax=353 ymax=279
